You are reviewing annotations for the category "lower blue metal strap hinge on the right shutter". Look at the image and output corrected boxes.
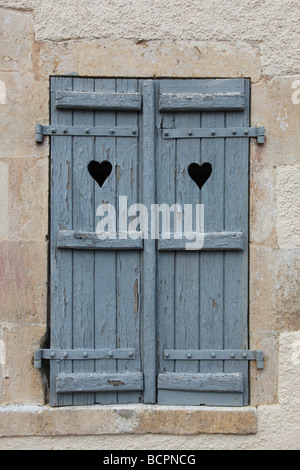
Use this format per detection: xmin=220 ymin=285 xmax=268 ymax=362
xmin=164 ymin=350 xmax=264 ymax=369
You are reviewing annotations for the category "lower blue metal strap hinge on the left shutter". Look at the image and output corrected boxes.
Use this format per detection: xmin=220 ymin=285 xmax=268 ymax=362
xmin=34 ymin=349 xmax=137 ymax=369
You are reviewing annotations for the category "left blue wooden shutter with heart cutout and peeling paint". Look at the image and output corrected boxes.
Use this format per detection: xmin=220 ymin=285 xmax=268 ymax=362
xmin=50 ymin=78 xmax=143 ymax=406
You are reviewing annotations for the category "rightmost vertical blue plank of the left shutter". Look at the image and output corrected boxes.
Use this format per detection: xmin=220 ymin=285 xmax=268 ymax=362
xmin=115 ymin=79 xmax=141 ymax=403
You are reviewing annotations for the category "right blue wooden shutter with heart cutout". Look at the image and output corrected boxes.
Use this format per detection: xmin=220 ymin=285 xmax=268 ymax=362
xmin=156 ymin=79 xmax=250 ymax=406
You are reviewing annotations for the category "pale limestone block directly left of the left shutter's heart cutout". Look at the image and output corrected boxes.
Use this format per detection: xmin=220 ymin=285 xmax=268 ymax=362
xmin=9 ymin=158 xmax=49 ymax=241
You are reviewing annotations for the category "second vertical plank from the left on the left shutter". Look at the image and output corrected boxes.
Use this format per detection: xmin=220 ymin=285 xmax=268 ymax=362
xmin=73 ymin=78 xmax=95 ymax=405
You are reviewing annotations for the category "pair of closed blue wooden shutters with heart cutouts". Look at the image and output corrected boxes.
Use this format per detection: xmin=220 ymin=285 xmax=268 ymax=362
xmin=50 ymin=77 xmax=250 ymax=406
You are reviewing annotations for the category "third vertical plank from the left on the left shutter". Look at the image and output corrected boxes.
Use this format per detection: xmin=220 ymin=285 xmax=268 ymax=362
xmin=95 ymin=79 xmax=118 ymax=405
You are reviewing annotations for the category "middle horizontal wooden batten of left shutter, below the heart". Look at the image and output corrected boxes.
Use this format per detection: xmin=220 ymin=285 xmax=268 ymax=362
xmin=57 ymin=230 xmax=143 ymax=251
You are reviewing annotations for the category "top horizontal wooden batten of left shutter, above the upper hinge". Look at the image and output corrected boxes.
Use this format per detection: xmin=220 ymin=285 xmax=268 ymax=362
xmin=56 ymin=91 xmax=142 ymax=111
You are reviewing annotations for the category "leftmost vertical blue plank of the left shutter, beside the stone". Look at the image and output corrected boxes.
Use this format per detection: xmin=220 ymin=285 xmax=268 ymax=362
xmin=50 ymin=77 xmax=73 ymax=406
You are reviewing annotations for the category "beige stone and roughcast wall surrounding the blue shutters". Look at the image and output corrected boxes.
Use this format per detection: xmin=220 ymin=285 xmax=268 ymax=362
xmin=0 ymin=0 xmax=300 ymax=449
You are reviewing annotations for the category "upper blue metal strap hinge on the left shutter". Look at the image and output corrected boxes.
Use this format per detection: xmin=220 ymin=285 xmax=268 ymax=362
xmin=35 ymin=124 xmax=139 ymax=143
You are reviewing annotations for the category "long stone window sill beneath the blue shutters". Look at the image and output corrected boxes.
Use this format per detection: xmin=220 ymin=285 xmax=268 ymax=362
xmin=0 ymin=405 xmax=257 ymax=437
